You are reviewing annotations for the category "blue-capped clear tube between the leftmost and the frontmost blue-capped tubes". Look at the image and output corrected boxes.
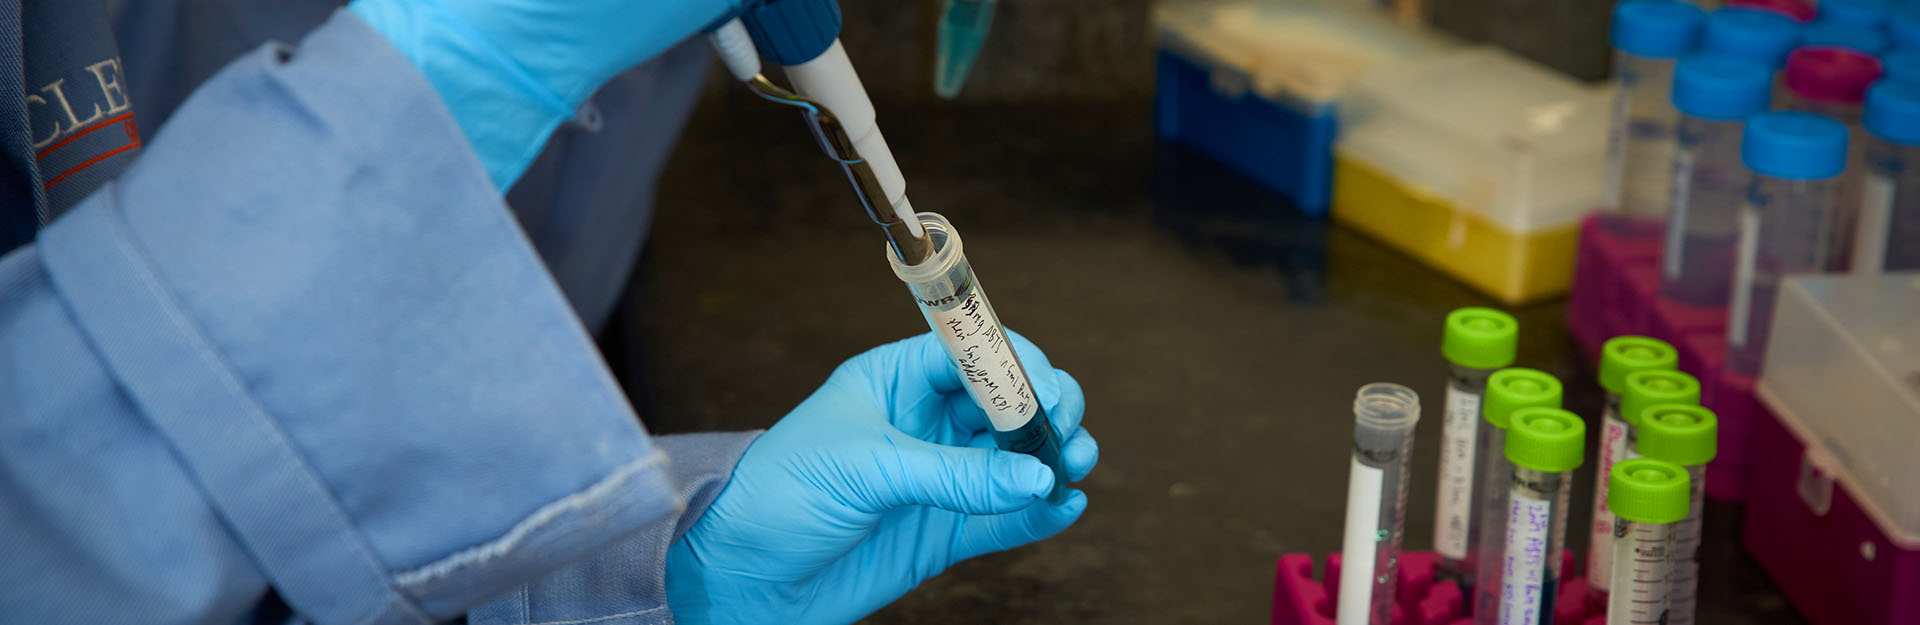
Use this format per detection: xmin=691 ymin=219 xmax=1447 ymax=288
xmin=1661 ymin=56 xmax=1786 ymax=307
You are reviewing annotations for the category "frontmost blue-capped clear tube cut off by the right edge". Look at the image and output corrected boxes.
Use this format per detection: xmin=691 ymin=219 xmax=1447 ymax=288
xmin=1851 ymin=81 xmax=1920 ymax=272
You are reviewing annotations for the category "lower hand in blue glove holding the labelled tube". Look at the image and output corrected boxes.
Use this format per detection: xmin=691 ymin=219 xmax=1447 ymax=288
xmin=666 ymin=334 xmax=1100 ymax=625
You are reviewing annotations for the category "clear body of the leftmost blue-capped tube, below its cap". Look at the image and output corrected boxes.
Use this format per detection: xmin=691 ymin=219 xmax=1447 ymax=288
xmin=1601 ymin=52 xmax=1678 ymax=236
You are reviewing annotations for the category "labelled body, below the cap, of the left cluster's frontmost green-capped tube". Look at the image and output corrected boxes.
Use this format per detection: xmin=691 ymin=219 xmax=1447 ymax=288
xmin=1500 ymin=466 xmax=1572 ymax=625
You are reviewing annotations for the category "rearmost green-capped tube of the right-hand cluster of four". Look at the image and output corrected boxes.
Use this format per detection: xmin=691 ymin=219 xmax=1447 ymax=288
xmin=1586 ymin=336 xmax=1680 ymax=592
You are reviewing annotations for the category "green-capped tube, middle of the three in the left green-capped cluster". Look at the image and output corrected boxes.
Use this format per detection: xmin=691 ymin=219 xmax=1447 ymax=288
xmin=1461 ymin=368 xmax=1561 ymax=625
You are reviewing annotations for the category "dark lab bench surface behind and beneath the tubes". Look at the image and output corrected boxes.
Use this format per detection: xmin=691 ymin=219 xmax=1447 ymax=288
xmin=605 ymin=98 xmax=1801 ymax=625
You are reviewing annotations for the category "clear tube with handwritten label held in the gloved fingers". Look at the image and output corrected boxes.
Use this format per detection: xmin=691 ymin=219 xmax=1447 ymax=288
xmin=887 ymin=213 xmax=1068 ymax=504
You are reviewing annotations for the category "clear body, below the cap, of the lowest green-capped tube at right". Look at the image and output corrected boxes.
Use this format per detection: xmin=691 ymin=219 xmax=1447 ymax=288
xmin=1607 ymin=520 xmax=1674 ymax=625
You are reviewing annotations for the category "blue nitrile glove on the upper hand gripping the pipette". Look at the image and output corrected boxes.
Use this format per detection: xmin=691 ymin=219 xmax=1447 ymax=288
xmin=348 ymin=0 xmax=755 ymax=190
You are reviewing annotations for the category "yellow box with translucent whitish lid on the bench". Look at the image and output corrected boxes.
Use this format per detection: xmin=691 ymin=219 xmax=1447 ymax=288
xmin=1334 ymin=48 xmax=1611 ymax=303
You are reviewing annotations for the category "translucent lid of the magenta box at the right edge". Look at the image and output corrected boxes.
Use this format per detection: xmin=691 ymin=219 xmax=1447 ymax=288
xmin=1759 ymin=272 xmax=1920 ymax=548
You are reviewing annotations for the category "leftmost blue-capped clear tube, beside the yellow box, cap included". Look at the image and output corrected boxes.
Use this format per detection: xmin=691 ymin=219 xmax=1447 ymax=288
xmin=1603 ymin=0 xmax=1701 ymax=236
